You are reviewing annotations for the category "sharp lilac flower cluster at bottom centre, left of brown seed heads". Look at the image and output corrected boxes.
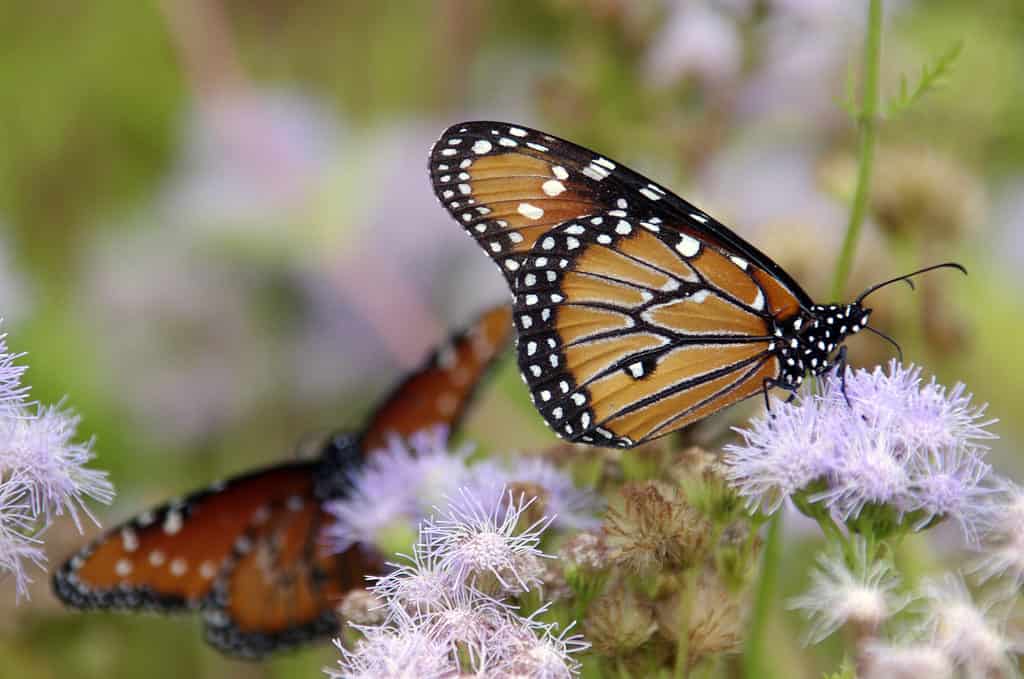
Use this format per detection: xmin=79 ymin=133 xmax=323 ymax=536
xmin=328 ymin=489 xmax=588 ymax=679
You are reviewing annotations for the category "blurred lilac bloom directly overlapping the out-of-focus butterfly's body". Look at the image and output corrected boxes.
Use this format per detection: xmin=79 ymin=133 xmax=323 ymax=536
xmin=325 ymin=428 xmax=469 ymax=552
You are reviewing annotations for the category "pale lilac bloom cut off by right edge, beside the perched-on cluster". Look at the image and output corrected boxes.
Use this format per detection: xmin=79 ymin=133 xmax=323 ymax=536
xmin=971 ymin=480 xmax=1024 ymax=590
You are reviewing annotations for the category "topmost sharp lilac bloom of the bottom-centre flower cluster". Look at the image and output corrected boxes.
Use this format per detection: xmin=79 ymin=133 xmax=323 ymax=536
xmin=422 ymin=489 xmax=552 ymax=592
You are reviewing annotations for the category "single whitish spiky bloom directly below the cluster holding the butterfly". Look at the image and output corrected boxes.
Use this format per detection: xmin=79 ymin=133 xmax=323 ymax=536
xmin=790 ymin=538 xmax=908 ymax=643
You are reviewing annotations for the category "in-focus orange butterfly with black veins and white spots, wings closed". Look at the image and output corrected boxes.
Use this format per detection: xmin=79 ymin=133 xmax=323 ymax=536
xmin=429 ymin=122 xmax=966 ymax=448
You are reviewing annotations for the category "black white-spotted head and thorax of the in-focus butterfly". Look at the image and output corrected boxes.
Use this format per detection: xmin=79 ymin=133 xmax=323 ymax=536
xmin=769 ymin=303 xmax=871 ymax=389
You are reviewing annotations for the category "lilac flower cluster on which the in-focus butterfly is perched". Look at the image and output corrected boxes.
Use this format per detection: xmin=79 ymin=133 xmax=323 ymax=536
xmin=725 ymin=362 xmax=994 ymax=542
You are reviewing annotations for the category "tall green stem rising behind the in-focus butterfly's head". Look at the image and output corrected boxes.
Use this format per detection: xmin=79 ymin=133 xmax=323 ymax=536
xmin=831 ymin=0 xmax=882 ymax=300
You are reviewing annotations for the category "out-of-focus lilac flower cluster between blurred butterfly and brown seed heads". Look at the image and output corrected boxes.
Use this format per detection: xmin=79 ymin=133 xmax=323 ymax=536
xmin=327 ymin=427 xmax=599 ymax=553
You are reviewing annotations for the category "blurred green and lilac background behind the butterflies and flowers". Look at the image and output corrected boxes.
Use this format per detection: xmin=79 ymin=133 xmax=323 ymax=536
xmin=0 ymin=0 xmax=1024 ymax=679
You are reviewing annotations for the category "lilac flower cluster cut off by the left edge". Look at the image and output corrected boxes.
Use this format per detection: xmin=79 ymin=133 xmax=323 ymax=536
xmin=0 ymin=327 xmax=114 ymax=597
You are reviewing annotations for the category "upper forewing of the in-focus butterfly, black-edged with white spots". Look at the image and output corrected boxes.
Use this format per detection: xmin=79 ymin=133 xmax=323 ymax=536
xmin=430 ymin=121 xmax=813 ymax=311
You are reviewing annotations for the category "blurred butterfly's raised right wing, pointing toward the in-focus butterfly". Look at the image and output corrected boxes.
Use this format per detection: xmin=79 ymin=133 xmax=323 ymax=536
xmin=362 ymin=304 xmax=512 ymax=451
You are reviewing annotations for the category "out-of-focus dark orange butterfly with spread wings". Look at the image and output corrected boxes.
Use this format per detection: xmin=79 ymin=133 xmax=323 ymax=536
xmin=52 ymin=305 xmax=512 ymax=659
